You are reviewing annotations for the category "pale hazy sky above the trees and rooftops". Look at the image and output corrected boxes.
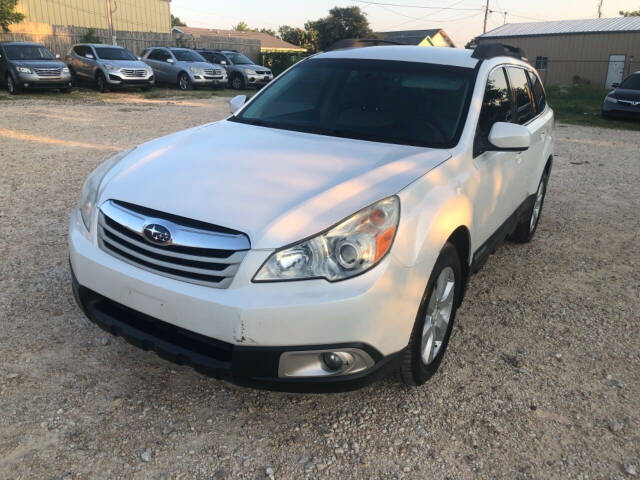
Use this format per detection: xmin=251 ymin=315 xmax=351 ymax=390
xmin=171 ymin=0 xmax=640 ymax=47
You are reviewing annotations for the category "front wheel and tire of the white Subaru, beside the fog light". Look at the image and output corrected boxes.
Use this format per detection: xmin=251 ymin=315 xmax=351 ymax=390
xmin=400 ymin=242 xmax=462 ymax=386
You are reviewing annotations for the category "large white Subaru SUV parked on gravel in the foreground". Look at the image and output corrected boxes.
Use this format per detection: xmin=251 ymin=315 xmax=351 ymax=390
xmin=69 ymin=45 xmax=554 ymax=391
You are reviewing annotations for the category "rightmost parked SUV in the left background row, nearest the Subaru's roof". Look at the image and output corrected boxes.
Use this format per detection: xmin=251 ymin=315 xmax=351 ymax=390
xmin=197 ymin=49 xmax=273 ymax=90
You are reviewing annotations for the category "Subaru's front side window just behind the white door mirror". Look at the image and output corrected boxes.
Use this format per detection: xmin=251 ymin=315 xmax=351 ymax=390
xmin=473 ymin=68 xmax=513 ymax=157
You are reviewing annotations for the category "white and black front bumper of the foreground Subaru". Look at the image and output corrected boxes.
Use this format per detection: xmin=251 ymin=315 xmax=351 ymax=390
xmin=69 ymin=210 xmax=420 ymax=391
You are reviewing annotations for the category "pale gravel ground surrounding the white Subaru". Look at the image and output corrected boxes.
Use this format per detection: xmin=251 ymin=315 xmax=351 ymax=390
xmin=0 ymin=94 xmax=640 ymax=479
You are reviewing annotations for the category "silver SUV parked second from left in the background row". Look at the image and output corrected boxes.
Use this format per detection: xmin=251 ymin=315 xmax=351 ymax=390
xmin=65 ymin=43 xmax=155 ymax=92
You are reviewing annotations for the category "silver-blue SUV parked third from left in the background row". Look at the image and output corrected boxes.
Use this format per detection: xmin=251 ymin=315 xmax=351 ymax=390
xmin=142 ymin=47 xmax=227 ymax=90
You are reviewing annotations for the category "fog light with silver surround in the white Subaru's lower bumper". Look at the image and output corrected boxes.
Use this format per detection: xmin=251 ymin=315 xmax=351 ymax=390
xmin=278 ymin=348 xmax=375 ymax=378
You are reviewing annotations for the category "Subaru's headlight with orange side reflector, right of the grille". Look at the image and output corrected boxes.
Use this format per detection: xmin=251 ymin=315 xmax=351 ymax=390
xmin=253 ymin=196 xmax=400 ymax=282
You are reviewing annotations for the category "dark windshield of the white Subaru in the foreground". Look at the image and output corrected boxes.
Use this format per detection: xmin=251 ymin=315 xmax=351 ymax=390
xmin=230 ymin=59 xmax=475 ymax=148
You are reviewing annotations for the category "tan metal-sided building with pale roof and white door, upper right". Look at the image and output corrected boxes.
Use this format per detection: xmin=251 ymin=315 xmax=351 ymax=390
xmin=477 ymin=17 xmax=640 ymax=88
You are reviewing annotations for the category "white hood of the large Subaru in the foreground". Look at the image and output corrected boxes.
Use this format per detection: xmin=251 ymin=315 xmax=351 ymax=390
xmin=98 ymin=121 xmax=450 ymax=249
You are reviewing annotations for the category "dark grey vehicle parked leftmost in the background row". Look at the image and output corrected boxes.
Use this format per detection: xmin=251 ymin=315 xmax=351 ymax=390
xmin=0 ymin=42 xmax=72 ymax=95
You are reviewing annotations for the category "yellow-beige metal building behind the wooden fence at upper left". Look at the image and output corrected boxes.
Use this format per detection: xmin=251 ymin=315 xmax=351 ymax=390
xmin=11 ymin=0 xmax=171 ymax=34
